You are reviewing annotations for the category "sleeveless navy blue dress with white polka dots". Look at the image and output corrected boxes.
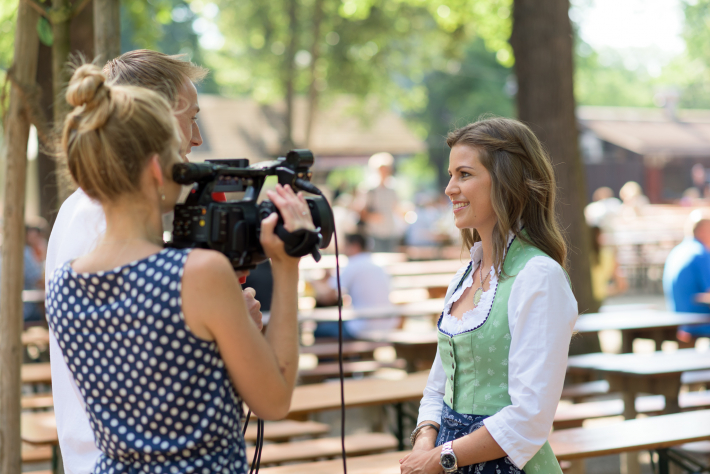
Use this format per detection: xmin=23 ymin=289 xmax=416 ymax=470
xmin=47 ymin=249 xmax=247 ymax=474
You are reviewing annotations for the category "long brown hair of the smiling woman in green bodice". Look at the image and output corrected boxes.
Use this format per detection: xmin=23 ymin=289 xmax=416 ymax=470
xmin=446 ymin=118 xmax=567 ymax=276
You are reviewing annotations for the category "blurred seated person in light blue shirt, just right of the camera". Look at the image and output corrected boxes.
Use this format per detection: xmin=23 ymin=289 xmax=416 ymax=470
xmin=311 ymin=234 xmax=400 ymax=339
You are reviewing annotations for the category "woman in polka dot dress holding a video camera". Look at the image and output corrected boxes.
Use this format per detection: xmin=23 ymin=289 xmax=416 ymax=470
xmin=47 ymin=65 xmax=313 ymax=474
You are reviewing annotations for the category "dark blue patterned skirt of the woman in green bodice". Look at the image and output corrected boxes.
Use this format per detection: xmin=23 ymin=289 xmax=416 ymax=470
xmin=436 ymin=403 xmax=525 ymax=474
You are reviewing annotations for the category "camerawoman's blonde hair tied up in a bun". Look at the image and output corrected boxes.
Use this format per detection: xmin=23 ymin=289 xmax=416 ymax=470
xmin=61 ymin=64 xmax=180 ymax=202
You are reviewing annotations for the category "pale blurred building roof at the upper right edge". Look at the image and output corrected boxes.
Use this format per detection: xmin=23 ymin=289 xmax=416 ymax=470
xmin=577 ymin=106 xmax=710 ymax=157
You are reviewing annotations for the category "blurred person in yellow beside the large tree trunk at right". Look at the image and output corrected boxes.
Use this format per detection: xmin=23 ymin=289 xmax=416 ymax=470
xmin=589 ymin=226 xmax=629 ymax=303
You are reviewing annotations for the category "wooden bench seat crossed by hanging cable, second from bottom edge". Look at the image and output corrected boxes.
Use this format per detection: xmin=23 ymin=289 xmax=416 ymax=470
xmin=247 ymin=433 xmax=397 ymax=464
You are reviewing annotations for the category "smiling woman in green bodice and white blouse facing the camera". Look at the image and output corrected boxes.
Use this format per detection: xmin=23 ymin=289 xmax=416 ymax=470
xmin=400 ymin=118 xmax=577 ymax=474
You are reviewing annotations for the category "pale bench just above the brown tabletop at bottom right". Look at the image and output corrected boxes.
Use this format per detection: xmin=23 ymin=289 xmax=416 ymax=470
xmin=553 ymin=391 xmax=710 ymax=429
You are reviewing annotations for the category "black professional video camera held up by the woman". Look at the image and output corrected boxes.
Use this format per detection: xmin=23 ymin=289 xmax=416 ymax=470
xmin=168 ymin=150 xmax=335 ymax=270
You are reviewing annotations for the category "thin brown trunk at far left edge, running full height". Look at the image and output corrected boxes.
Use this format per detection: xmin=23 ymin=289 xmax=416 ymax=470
xmin=0 ymin=0 xmax=39 ymax=473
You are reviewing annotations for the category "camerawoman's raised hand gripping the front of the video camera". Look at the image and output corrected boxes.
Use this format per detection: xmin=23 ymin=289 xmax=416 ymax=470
xmin=259 ymin=184 xmax=315 ymax=262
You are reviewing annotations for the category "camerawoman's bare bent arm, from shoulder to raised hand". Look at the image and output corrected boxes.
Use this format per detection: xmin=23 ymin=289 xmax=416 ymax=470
xmin=182 ymin=187 xmax=313 ymax=419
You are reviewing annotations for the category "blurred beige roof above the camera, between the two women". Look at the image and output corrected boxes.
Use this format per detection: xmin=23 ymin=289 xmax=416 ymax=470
xmin=190 ymin=94 xmax=425 ymax=169
